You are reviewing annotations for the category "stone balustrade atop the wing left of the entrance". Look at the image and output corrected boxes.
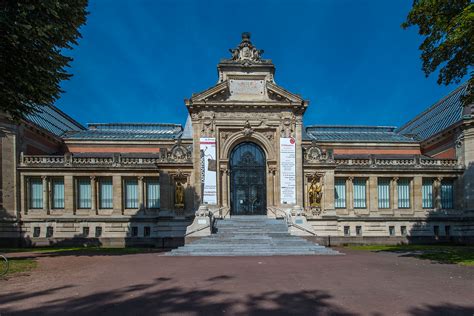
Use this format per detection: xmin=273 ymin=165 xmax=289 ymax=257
xmin=20 ymin=153 xmax=192 ymax=167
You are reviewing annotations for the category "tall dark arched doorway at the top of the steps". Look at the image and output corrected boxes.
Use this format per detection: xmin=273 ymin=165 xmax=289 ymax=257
xmin=229 ymin=142 xmax=267 ymax=215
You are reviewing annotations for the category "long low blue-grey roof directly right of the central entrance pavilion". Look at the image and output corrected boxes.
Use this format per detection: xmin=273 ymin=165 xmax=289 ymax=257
xmin=305 ymin=126 xmax=416 ymax=143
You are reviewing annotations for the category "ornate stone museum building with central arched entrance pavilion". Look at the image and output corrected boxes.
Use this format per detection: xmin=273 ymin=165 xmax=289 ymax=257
xmin=0 ymin=33 xmax=474 ymax=247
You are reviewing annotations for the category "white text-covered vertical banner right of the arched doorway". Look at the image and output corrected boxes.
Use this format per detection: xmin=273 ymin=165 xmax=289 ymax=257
xmin=280 ymin=137 xmax=296 ymax=204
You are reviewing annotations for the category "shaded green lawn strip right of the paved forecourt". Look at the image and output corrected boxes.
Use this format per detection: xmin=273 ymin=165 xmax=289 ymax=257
xmin=347 ymin=245 xmax=474 ymax=266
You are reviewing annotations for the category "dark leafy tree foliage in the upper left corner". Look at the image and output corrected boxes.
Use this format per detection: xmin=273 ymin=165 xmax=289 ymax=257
xmin=0 ymin=0 xmax=88 ymax=120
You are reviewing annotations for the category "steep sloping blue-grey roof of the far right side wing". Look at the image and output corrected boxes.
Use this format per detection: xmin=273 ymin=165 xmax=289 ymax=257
xmin=397 ymin=82 xmax=472 ymax=140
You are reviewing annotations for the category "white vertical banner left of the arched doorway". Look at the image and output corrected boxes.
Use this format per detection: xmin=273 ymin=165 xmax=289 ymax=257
xmin=199 ymin=137 xmax=217 ymax=204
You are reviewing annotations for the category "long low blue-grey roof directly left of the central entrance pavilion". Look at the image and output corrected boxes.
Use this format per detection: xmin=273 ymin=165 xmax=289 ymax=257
xmin=64 ymin=123 xmax=183 ymax=140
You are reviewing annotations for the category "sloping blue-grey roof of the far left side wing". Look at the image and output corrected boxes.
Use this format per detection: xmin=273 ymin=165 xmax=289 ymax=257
xmin=25 ymin=105 xmax=85 ymax=137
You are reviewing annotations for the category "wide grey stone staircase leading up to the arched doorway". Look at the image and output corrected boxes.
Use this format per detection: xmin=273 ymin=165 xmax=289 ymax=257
xmin=167 ymin=216 xmax=341 ymax=256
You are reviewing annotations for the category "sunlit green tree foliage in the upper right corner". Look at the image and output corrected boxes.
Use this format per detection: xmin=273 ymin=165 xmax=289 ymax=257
xmin=402 ymin=0 xmax=474 ymax=105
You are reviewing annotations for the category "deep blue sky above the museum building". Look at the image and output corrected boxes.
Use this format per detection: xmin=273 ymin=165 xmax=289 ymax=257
xmin=56 ymin=0 xmax=462 ymax=126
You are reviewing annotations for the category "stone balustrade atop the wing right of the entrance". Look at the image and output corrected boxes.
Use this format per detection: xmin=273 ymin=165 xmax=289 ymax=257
xmin=334 ymin=157 xmax=461 ymax=168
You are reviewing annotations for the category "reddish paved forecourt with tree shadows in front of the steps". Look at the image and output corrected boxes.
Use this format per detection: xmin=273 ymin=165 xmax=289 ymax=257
xmin=0 ymin=249 xmax=474 ymax=316
